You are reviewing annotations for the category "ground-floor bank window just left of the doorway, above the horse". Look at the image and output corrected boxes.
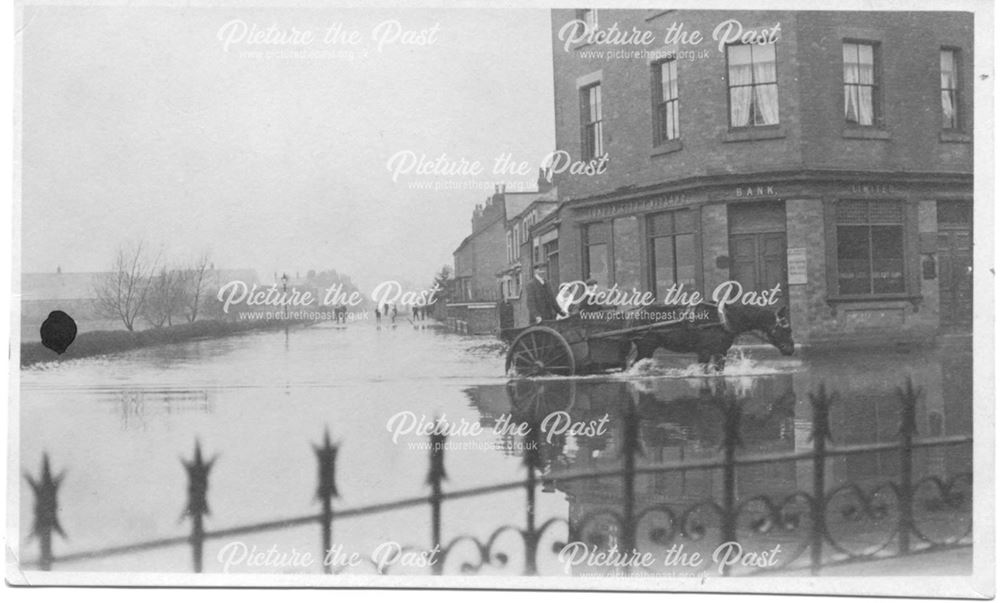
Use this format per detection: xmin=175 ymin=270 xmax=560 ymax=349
xmin=647 ymin=210 xmax=697 ymax=298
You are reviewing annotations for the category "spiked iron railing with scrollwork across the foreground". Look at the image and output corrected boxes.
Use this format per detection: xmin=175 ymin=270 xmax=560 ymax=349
xmin=24 ymin=381 xmax=972 ymax=575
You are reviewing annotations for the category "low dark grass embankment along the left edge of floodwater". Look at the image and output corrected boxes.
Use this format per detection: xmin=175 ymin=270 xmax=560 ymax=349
xmin=21 ymin=320 xmax=306 ymax=366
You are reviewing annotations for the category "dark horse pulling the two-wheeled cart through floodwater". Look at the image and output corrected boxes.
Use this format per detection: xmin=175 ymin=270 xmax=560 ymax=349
xmin=627 ymin=302 xmax=795 ymax=372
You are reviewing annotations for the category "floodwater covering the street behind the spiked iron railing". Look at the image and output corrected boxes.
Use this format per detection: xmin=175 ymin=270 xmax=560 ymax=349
xmin=11 ymin=322 xmax=973 ymax=575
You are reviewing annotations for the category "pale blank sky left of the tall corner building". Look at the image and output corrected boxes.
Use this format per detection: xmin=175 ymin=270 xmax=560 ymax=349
xmin=19 ymin=6 xmax=555 ymax=287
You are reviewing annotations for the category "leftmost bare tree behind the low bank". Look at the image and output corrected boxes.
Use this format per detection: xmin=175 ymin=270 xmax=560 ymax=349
xmin=95 ymin=242 xmax=155 ymax=331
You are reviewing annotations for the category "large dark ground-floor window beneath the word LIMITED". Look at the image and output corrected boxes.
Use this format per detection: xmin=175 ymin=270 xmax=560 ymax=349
xmin=836 ymin=201 xmax=906 ymax=295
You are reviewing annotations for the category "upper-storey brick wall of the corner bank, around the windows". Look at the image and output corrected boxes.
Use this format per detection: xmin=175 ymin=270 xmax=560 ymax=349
xmin=552 ymin=9 xmax=974 ymax=199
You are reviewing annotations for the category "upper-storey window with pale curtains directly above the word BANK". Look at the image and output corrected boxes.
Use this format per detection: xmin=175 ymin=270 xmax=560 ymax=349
xmin=726 ymin=43 xmax=778 ymax=128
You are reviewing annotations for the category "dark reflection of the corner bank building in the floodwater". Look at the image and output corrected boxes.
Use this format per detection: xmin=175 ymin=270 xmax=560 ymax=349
xmin=468 ymin=347 xmax=972 ymax=572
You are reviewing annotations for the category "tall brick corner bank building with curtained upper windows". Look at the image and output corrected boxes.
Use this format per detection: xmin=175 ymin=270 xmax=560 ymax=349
xmin=552 ymin=9 xmax=973 ymax=343
